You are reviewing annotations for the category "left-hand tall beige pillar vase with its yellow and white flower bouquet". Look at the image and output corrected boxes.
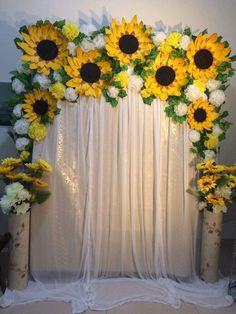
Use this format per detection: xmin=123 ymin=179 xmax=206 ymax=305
xmin=0 ymin=155 xmax=52 ymax=290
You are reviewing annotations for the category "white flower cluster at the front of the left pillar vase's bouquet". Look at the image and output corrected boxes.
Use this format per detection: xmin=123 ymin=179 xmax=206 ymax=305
xmin=0 ymin=182 xmax=31 ymax=215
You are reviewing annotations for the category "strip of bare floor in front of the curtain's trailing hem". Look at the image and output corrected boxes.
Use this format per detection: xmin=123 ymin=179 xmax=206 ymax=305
xmin=0 ymin=302 xmax=236 ymax=314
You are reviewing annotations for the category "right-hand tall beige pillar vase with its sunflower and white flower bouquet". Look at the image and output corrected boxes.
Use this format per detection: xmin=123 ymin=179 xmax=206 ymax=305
xmin=197 ymin=160 xmax=236 ymax=283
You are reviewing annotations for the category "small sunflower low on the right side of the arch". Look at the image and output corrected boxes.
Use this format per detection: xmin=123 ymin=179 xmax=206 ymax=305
xmin=187 ymin=98 xmax=219 ymax=132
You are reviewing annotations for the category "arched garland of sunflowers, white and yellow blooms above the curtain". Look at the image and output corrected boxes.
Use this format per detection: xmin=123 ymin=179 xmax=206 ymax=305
xmin=10 ymin=16 xmax=236 ymax=161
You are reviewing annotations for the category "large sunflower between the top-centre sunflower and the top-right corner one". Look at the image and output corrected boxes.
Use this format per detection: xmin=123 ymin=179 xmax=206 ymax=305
xmin=141 ymin=53 xmax=188 ymax=100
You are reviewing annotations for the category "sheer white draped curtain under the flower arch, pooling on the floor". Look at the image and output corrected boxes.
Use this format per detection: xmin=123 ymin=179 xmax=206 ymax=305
xmin=2 ymin=91 xmax=232 ymax=313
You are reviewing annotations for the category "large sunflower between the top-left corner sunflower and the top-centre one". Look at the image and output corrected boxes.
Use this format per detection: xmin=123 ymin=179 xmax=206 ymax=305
xmin=64 ymin=48 xmax=112 ymax=97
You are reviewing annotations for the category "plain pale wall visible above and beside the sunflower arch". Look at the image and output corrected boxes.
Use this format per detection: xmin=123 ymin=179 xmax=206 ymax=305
xmin=0 ymin=0 xmax=236 ymax=236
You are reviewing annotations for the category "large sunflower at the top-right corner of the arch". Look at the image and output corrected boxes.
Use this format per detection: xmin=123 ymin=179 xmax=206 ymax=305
xmin=186 ymin=34 xmax=230 ymax=81
